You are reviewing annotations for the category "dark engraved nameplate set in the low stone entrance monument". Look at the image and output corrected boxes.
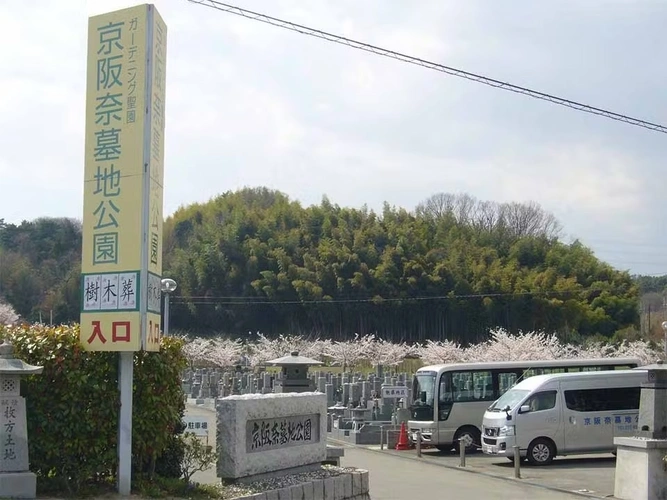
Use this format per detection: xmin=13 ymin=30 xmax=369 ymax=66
xmin=246 ymin=414 xmax=320 ymax=453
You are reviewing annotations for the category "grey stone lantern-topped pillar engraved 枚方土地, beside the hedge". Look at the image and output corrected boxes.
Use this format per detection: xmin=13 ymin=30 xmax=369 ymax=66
xmin=0 ymin=342 xmax=44 ymax=498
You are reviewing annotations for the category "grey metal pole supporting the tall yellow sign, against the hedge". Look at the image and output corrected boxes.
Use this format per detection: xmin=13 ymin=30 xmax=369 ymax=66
xmin=118 ymin=352 xmax=134 ymax=496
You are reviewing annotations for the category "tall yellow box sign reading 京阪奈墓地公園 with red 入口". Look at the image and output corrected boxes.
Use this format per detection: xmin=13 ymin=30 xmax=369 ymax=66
xmin=80 ymin=5 xmax=167 ymax=352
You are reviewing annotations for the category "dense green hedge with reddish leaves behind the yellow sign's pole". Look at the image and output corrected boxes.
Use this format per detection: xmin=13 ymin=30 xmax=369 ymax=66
xmin=0 ymin=325 xmax=186 ymax=491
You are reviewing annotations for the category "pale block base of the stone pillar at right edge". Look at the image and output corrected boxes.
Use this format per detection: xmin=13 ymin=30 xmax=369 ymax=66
xmin=614 ymin=437 xmax=667 ymax=500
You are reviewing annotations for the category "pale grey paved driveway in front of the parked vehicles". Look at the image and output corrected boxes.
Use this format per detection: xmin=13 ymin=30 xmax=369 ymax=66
xmin=187 ymin=405 xmax=615 ymax=500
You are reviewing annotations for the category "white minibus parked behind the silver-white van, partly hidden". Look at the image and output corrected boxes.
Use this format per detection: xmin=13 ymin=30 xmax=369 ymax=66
xmin=408 ymin=358 xmax=640 ymax=452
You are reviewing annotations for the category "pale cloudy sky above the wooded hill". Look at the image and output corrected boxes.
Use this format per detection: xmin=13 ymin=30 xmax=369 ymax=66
xmin=0 ymin=0 xmax=667 ymax=275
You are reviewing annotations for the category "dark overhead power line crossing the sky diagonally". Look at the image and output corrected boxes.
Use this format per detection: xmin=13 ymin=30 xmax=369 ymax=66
xmin=188 ymin=0 xmax=667 ymax=134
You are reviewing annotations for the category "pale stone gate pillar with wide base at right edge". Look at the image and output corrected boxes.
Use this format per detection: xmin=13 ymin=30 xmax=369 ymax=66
xmin=614 ymin=361 xmax=667 ymax=500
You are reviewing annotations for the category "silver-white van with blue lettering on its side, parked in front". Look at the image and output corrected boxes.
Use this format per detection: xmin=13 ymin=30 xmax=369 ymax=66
xmin=482 ymin=368 xmax=648 ymax=465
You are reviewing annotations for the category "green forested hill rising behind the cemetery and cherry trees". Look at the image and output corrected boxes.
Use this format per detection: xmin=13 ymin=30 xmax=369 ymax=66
xmin=0 ymin=188 xmax=638 ymax=342
